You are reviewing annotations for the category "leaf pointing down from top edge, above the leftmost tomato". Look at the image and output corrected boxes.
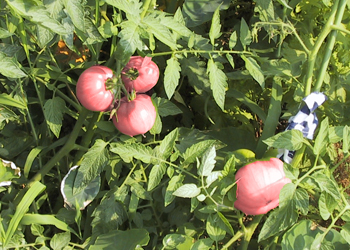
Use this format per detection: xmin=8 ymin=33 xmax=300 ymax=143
xmin=64 ymin=0 xmax=85 ymax=32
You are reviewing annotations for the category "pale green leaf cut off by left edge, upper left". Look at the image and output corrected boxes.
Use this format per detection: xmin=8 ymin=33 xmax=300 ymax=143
xmin=0 ymin=52 xmax=27 ymax=79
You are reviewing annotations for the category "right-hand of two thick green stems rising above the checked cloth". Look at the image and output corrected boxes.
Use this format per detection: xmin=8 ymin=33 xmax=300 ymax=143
xmin=314 ymin=0 xmax=347 ymax=92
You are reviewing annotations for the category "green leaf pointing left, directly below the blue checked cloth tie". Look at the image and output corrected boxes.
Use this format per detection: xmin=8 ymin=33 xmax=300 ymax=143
xmin=264 ymin=129 xmax=305 ymax=150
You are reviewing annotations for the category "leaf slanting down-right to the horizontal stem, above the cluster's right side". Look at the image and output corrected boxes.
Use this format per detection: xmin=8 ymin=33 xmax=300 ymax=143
xmin=142 ymin=15 xmax=177 ymax=50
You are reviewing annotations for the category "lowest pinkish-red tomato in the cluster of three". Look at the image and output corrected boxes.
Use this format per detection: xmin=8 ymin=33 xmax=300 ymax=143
xmin=113 ymin=94 xmax=156 ymax=136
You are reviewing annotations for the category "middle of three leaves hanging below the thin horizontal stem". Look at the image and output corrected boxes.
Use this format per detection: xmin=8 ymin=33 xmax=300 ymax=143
xmin=207 ymin=59 xmax=228 ymax=110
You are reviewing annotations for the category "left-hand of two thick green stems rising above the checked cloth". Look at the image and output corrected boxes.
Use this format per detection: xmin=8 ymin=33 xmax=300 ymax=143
xmin=304 ymin=0 xmax=343 ymax=96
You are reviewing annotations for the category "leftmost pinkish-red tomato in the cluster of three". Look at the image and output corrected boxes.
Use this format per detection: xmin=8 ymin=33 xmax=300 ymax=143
xmin=76 ymin=65 xmax=114 ymax=111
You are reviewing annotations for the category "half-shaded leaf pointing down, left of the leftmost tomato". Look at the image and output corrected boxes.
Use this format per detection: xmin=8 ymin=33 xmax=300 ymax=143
xmin=44 ymin=97 xmax=66 ymax=138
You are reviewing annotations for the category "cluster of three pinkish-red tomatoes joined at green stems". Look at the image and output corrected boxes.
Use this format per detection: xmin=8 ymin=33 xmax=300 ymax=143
xmin=76 ymin=56 xmax=159 ymax=136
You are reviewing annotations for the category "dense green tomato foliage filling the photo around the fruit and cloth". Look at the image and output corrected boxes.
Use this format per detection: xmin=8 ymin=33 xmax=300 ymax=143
xmin=0 ymin=0 xmax=350 ymax=250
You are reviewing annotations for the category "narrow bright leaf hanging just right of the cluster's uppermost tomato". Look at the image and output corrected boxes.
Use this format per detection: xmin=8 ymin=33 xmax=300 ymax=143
xmin=164 ymin=57 xmax=181 ymax=99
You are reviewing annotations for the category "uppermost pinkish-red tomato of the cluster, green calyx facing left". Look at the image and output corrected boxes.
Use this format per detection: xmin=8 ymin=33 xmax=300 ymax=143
xmin=122 ymin=56 xmax=159 ymax=93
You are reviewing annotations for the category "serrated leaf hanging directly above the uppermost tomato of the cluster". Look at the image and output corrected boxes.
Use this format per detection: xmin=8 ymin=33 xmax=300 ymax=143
xmin=118 ymin=20 xmax=143 ymax=55
